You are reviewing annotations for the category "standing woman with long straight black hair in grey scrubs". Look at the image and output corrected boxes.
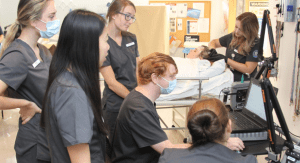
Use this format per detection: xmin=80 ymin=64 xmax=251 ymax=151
xmin=41 ymin=10 xmax=109 ymax=163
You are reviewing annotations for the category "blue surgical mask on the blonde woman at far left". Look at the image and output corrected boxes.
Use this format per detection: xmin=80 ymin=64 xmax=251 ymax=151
xmin=35 ymin=19 xmax=60 ymax=38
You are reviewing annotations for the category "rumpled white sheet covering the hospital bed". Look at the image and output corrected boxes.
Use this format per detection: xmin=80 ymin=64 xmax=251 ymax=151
xmin=157 ymin=57 xmax=233 ymax=101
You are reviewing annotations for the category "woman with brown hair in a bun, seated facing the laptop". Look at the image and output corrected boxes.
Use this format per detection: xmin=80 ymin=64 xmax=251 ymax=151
xmin=158 ymin=98 xmax=257 ymax=163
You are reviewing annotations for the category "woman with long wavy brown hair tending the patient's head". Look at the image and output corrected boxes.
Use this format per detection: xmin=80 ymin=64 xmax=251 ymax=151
xmin=209 ymin=12 xmax=259 ymax=81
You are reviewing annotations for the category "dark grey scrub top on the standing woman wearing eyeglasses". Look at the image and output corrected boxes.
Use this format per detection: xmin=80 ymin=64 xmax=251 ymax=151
xmin=102 ymin=32 xmax=140 ymax=112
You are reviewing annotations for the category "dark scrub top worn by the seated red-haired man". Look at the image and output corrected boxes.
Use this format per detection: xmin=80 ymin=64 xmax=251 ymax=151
xmin=112 ymin=89 xmax=168 ymax=163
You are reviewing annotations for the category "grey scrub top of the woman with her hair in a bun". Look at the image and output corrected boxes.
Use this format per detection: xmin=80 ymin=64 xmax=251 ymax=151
xmin=158 ymin=143 xmax=257 ymax=163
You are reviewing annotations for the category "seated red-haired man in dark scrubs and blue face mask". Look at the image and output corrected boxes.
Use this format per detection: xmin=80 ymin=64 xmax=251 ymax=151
xmin=112 ymin=53 xmax=190 ymax=163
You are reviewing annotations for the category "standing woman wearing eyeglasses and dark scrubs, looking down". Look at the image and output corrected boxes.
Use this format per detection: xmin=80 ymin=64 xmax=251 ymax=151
xmin=100 ymin=0 xmax=139 ymax=140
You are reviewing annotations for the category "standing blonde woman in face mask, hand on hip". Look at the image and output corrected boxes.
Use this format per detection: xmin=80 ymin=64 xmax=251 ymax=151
xmin=0 ymin=0 xmax=60 ymax=163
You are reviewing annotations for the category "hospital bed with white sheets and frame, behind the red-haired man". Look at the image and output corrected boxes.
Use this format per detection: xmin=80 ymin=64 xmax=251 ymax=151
xmin=101 ymin=57 xmax=233 ymax=140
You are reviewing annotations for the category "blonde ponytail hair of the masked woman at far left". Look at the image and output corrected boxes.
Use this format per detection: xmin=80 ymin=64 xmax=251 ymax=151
xmin=0 ymin=0 xmax=48 ymax=57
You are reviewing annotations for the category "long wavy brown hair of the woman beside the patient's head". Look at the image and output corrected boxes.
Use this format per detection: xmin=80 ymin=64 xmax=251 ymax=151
xmin=229 ymin=12 xmax=259 ymax=55
